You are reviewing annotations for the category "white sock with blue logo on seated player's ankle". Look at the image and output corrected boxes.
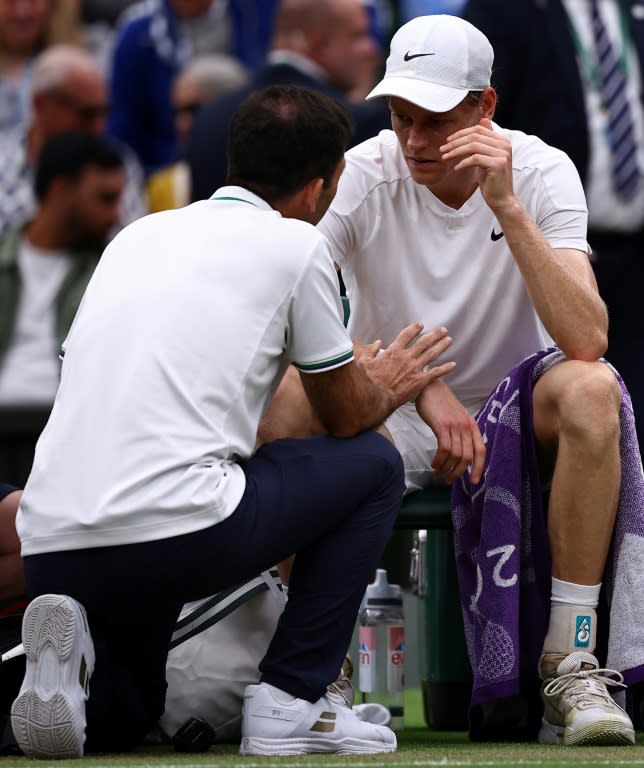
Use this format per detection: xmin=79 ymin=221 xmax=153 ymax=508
xmin=542 ymin=578 xmax=601 ymax=653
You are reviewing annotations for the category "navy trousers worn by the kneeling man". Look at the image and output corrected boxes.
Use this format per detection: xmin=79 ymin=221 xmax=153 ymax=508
xmin=25 ymin=432 xmax=404 ymax=751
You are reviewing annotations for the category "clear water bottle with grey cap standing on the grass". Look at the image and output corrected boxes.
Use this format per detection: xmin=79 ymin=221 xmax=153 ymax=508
xmin=358 ymin=568 xmax=405 ymax=730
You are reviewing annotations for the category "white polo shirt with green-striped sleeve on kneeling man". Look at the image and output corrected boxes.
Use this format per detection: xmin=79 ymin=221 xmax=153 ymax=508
xmin=17 ymin=187 xmax=353 ymax=555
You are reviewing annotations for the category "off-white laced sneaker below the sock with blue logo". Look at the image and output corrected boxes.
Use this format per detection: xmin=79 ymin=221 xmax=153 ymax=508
xmin=539 ymin=651 xmax=635 ymax=746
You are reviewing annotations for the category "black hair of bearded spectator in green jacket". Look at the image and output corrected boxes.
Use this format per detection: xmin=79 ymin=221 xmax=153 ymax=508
xmin=34 ymin=131 xmax=123 ymax=202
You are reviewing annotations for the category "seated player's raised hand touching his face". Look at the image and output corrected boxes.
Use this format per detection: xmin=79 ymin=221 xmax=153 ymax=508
xmin=440 ymin=117 xmax=515 ymax=211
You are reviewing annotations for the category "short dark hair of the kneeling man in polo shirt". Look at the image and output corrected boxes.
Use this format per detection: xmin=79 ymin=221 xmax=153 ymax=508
xmin=226 ymin=85 xmax=353 ymax=205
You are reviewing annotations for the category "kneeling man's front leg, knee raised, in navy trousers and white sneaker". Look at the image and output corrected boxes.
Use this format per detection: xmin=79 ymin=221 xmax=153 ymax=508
xmin=214 ymin=433 xmax=403 ymax=754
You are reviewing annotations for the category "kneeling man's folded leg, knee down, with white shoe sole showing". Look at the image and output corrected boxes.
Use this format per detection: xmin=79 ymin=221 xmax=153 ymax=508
xmin=12 ymin=545 xmax=181 ymax=759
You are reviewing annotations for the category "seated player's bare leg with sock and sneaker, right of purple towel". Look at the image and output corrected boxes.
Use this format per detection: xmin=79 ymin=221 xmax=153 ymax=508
xmin=533 ymin=361 xmax=634 ymax=744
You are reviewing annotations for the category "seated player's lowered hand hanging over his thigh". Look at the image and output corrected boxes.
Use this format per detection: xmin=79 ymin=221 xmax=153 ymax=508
xmin=416 ymin=381 xmax=485 ymax=485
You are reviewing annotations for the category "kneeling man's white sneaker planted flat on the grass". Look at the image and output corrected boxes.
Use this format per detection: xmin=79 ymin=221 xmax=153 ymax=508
xmin=239 ymin=683 xmax=396 ymax=755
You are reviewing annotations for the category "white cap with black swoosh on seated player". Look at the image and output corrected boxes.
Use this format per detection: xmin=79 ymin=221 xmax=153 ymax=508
xmin=367 ymin=14 xmax=494 ymax=112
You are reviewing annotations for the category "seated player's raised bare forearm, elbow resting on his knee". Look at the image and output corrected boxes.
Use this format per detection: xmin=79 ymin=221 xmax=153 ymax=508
xmin=496 ymin=201 xmax=608 ymax=360
